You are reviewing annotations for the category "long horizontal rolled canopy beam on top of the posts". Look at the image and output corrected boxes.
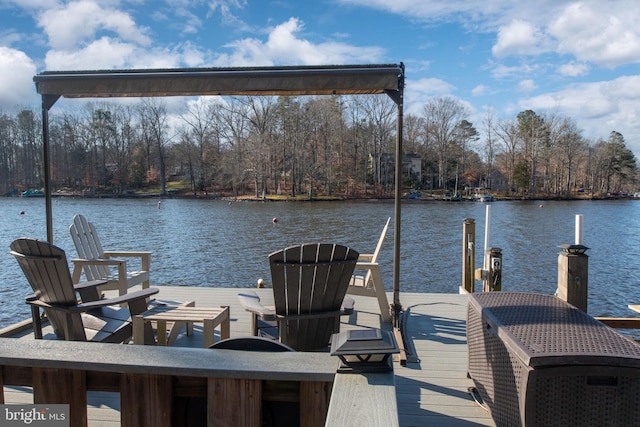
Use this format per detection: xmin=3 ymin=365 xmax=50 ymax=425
xmin=33 ymin=65 xmax=404 ymax=102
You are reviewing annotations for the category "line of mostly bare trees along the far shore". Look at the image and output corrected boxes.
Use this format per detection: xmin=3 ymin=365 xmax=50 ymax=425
xmin=0 ymin=96 xmax=638 ymax=198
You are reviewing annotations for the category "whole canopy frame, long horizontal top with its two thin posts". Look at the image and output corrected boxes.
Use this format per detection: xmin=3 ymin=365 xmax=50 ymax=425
xmin=33 ymin=63 xmax=404 ymax=327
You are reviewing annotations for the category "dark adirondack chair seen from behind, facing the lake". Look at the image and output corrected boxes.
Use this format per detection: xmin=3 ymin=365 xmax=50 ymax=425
xmin=239 ymin=243 xmax=358 ymax=351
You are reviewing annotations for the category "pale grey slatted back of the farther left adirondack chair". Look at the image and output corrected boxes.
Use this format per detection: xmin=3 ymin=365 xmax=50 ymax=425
xmin=69 ymin=214 xmax=111 ymax=280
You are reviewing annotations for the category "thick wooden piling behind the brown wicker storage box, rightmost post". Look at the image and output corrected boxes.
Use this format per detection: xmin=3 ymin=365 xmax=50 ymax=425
xmin=558 ymin=245 xmax=589 ymax=312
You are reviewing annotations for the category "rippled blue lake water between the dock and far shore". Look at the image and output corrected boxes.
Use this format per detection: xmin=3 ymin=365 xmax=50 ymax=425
xmin=0 ymin=198 xmax=640 ymax=327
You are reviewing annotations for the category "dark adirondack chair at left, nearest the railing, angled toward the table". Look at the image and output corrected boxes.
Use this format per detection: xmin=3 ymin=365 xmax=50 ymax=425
xmin=11 ymin=238 xmax=158 ymax=343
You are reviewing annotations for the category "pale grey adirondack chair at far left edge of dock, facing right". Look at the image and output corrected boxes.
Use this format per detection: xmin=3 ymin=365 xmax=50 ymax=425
xmin=69 ymin=214 xmax=151 ymax=295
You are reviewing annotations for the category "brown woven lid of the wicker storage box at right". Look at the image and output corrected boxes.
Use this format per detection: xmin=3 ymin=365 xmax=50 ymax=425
xmin=469 ymin=292 xmax=640 ymax=367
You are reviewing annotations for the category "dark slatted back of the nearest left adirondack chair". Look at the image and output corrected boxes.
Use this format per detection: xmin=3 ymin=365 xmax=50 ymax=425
xmin=10 ymin=238 xmax=86 ymax=341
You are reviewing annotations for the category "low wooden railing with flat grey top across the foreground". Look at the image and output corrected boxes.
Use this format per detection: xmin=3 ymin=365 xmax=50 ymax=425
xmin=0 ymin=338 xmax=398 ymax=427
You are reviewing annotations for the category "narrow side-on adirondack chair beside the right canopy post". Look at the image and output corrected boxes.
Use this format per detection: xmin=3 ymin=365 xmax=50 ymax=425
xmin=347 ymin=218 xmax=391 ymax=323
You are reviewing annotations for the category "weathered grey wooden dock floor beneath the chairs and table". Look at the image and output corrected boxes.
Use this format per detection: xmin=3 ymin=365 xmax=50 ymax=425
xmin=5 ymin=286 xmax=494 ymax=427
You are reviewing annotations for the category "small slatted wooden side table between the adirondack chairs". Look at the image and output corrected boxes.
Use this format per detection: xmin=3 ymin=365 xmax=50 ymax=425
xmin=133 ymin=305 xmax=231 ymax=348
